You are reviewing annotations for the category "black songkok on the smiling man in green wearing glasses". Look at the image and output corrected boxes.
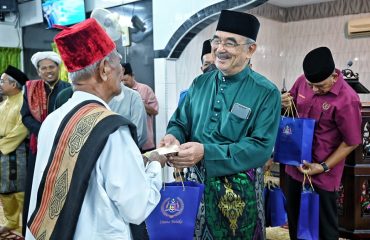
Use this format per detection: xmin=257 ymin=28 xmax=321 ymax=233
xmin=216 ymin=10 xmax=260 ymax=41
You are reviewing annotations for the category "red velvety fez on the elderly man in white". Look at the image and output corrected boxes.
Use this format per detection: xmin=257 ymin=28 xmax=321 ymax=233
xmin=54 ymin=18 xmax=116 ymax=72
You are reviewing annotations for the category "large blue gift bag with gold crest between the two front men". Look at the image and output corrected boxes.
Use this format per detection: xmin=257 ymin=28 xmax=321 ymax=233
xmin=145 ymin=181 xmax=204 ymax=240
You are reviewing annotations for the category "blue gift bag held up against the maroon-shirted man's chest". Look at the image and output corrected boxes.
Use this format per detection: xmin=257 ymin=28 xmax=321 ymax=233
xmin=274 ymin=116 xmax=315 ymax=166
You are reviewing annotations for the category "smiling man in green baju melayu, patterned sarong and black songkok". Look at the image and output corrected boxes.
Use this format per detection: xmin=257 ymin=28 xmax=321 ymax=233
xmin=160 ymin=10 xmax=281 ymax=240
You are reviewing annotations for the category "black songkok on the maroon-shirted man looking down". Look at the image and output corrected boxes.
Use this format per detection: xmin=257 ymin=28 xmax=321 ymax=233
xmin=303 ymin=47 xmax=335 ymax=83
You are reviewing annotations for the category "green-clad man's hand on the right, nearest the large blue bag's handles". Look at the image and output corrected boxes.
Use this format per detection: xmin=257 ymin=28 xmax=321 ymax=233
xmin=169 ymin=142 xmax=204 ymax=168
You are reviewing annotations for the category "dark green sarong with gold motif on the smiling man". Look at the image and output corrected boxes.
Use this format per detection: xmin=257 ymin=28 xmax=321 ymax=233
xmin=205 ymin=170 xmax=261 ymax=240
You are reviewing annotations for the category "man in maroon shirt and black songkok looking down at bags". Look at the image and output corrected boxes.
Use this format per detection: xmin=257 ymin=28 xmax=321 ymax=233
xmin=281 ymin=47 xmax=362 ymax=239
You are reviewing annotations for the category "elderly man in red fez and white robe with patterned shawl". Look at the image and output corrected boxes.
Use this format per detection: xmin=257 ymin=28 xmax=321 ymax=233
xmin=26 ymin=19 xmax=165 ymax=239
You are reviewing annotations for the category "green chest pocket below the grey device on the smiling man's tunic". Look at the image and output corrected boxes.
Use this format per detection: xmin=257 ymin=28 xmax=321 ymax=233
xmin=220 ymin=112 xmax=248 ymax=142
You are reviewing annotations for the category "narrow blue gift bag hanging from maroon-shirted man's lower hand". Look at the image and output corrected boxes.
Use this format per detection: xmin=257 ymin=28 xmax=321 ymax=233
xmin=297 ymin=173 xmax=320 ymax=240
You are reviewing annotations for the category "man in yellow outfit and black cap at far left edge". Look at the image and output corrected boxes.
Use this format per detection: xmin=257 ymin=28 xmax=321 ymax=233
xmin=0 ymin=65 xmax=28 ymax=233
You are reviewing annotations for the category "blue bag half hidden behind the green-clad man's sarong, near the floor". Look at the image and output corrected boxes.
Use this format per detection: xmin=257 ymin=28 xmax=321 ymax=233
xmin=265 ymin=187 xmax=288 ymax=227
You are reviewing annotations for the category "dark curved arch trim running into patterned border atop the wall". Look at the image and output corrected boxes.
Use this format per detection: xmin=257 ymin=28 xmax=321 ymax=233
xmin=155 ymin=0 xmax=370 ymax=59
